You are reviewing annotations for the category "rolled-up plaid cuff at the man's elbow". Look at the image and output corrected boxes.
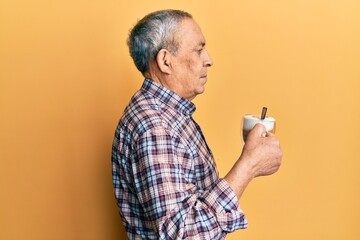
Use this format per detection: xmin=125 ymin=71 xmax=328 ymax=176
xmin=203 ymin=179 xmax=248 ymax=232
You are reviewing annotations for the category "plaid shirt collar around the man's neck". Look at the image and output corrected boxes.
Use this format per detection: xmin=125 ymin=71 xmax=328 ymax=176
xmin=141 ymin=78 xmax=196 ymax=116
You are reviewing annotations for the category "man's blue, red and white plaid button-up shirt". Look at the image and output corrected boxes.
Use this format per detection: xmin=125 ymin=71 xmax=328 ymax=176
xmin=112 ymin=79 xmax=247 ymax=239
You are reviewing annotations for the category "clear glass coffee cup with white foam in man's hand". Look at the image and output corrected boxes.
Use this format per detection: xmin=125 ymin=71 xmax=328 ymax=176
xmin=242 ymin=114 xmax=276 ymax=142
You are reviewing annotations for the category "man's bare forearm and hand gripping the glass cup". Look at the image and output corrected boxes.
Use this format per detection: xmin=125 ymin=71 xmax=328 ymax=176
xmin=224 ymin=124 xmax=282 ymax=199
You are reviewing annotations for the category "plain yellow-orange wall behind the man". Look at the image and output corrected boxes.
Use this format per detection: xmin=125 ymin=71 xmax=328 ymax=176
xmin=0 ymin=0 xmax=360 ymax=240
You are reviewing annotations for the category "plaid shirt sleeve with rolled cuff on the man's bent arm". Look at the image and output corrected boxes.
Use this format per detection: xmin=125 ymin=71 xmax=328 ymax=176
xmin=132 ymin=128 xmax=247 ymax=239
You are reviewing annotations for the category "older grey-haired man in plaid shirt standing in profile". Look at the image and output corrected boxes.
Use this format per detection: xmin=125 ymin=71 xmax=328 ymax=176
xmin=112 ymin=10 xmax=282 ymax=239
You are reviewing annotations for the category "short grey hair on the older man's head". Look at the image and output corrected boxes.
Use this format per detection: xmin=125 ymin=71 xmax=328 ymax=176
xmin=127 ymin=10 xmax=192 ymax=73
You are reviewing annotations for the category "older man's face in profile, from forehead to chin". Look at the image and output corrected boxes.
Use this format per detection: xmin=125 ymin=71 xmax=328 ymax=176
xmin=172 ymin=19 xmax=213 ymax=100
